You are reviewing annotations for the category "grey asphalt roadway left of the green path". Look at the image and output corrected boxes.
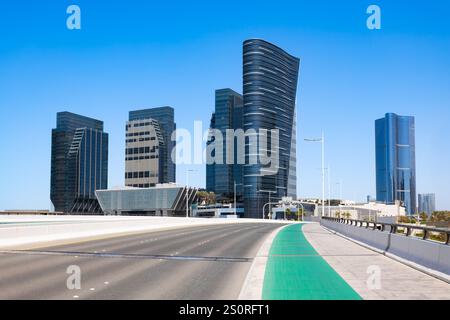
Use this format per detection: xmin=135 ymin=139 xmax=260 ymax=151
xmin=0 ymin=224 xmax=280 ymax=299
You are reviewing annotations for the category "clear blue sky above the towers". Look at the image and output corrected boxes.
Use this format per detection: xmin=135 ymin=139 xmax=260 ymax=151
xmin=0 ymin=0 xmax=450 ymax=210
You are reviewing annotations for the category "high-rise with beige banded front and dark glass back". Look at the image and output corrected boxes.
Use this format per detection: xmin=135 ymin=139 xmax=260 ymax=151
xmin=125 ymin=107 xmax=176 ymax=188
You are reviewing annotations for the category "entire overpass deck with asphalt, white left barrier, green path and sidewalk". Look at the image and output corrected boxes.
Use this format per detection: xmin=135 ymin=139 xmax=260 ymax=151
xmin=0 ymin=216 xmax=450 ymax=300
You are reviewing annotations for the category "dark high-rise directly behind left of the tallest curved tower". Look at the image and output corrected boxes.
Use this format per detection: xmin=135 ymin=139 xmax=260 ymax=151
xmin=206 ymin=89 xmax=243 ymax=201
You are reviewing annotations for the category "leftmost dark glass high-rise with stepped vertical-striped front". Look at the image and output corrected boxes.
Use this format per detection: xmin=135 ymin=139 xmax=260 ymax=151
xmin=50 ymin=112 xmax=108 ymax=213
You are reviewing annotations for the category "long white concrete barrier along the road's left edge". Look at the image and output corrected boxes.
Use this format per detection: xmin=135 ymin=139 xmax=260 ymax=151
xmin=0 ymin=216 xmax=285 ymax=249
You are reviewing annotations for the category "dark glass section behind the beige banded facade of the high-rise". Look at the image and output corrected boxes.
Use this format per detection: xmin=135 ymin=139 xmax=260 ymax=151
xmin=129 ymin=107 xmax=176 ymax=183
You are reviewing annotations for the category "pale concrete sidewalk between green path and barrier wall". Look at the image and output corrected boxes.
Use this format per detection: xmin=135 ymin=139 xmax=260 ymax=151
xmin=303 ymin=224 xmax=450 ymax=300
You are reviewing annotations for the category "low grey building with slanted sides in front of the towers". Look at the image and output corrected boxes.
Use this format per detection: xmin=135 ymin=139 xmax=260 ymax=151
xmin=96 ymin=184 xmax=197 ymax=217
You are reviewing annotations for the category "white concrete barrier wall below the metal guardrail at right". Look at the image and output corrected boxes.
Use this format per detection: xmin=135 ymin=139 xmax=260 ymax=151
xmin=321 ymin=220 xmax=450 ymax=275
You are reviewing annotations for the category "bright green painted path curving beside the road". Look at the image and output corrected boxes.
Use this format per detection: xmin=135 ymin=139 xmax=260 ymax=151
xmin=262 ymin=224 xmax=361 ymax=300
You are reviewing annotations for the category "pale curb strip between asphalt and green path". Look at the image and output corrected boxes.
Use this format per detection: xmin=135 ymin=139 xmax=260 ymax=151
xmin=238 ymin=225 xmax=289 ymax=300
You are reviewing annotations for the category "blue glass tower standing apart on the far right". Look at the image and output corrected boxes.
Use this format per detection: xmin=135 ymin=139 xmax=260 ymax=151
xmin=375 ymin=113 xmax=416 ymax=215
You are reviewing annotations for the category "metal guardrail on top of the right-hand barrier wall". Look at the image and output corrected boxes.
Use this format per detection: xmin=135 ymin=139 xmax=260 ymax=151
xmin=322 ymin=217 xmax=450 ymax=245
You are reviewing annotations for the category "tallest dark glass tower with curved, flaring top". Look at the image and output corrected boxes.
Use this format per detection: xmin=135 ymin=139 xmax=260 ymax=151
xmin=243 ymin=39 xmax=300 ymax=218
